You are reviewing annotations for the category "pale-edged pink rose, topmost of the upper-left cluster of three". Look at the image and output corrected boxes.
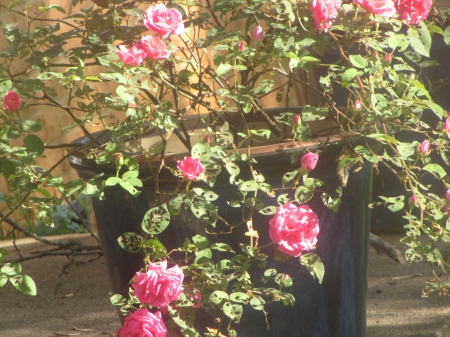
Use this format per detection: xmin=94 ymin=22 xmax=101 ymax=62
xmin=144 ymin=4 xmax=184 ymax=37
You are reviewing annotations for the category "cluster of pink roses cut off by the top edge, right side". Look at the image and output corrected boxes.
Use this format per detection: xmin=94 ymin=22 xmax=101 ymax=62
xmin=311 ymin=0 xmax=431 ymax=31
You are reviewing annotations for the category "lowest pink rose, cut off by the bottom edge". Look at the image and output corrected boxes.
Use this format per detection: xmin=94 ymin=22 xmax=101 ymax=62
xmin=120 ymin=308 xmax=167 ymax=337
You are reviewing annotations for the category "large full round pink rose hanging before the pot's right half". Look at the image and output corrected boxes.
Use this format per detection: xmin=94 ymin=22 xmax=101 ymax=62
xmin=269 ymin=203 xmax=319 ymax=256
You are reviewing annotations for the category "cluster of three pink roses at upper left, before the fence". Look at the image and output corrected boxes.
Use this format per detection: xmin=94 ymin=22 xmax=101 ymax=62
xmin=117 ymin=4 xmax=184 ymax=66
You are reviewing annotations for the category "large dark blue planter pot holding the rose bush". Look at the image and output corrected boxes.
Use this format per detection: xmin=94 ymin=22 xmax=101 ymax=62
xmin=69 ymin=133 xmax=372 ymax=337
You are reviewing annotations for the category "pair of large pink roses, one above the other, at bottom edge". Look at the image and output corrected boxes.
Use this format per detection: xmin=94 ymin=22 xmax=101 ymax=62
xmin=114 ymin=261 xmax=184 ymax=337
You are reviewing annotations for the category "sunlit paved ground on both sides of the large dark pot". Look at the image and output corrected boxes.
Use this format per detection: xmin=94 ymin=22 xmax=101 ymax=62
xmin=0 ymin=235 xmax=450 ymax=337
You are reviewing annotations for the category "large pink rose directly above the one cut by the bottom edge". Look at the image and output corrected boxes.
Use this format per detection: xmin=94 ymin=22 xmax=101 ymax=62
xmin=131 ymin=261 xmax=184 ymax=307
